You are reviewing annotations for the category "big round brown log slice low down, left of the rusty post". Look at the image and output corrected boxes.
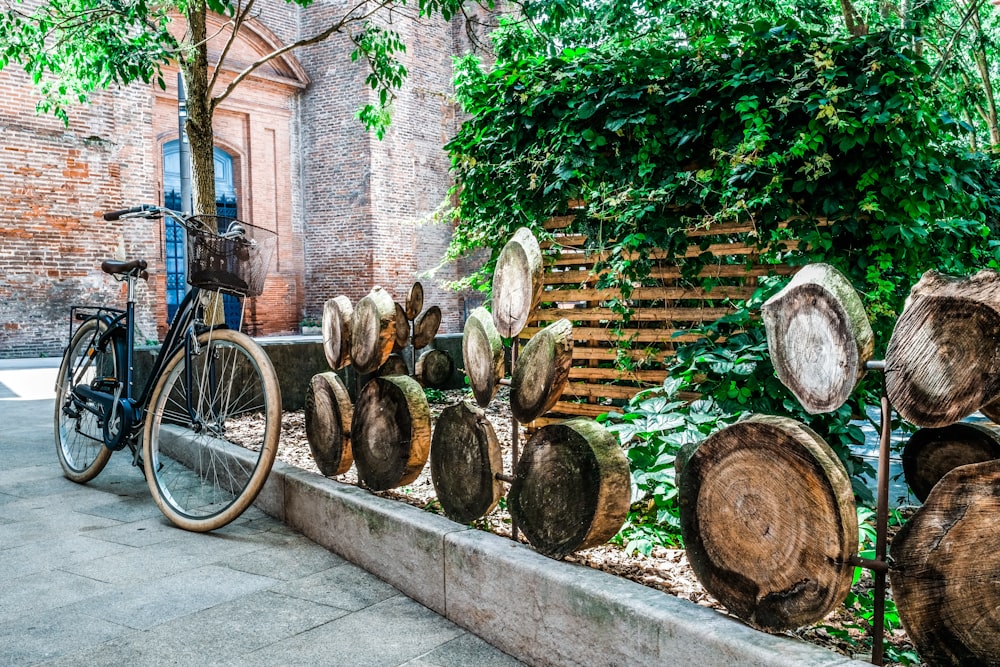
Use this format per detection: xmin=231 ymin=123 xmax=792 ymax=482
xmin=678 ymin=415 xmax=858 ymax=631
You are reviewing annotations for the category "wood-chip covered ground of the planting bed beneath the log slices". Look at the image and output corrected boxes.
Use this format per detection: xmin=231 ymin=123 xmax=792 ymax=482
xmin=278 ymin=388 xmax=919 ymax=665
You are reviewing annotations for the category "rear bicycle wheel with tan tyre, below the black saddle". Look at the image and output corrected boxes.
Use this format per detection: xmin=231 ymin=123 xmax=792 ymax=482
xmin=54 ymin=318 xmax=118 ymax=484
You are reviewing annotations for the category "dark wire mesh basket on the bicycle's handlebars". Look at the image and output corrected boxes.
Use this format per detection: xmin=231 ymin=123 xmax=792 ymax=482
xmin=187 ymin=215 xmax=278 ymax=296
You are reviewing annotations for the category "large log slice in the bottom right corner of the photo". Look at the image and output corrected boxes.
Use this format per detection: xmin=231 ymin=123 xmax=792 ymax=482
xmin=889 ymin=460 xmax=1000 ymax=667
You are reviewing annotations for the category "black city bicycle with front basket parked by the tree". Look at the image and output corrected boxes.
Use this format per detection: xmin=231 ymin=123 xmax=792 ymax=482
xmin=55 ymin=204 xmax=281 ymax=532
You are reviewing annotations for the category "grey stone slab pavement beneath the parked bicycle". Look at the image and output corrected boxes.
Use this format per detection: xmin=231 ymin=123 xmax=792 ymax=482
xmin=0 ymin=359 xmax=521 ymax=667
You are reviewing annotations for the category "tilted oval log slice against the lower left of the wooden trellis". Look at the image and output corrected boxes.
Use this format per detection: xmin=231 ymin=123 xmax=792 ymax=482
xmin=510 ymin=319 xmax=573 ymax=424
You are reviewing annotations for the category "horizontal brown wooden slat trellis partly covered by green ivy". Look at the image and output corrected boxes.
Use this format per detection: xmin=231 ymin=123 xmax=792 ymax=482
xmin=520 ymin=211 xmax=796 ymax=428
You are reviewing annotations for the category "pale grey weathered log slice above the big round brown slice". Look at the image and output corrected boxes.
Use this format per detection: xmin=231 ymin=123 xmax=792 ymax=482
xmin=761 ymin=264 xmax=875 ymax=414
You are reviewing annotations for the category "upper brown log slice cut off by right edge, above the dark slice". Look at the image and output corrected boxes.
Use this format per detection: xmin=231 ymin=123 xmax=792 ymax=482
xmin=885 ymin=271 xmax=1000 ymax=427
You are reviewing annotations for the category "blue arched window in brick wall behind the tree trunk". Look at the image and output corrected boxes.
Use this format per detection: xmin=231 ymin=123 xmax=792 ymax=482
xmin=163 ymin=139 xmax=239 ymax=328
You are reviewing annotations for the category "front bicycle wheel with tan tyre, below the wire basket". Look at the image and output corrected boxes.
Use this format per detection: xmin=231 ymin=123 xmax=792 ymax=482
xmin=143 ymin=329 xmax=281 ymax=532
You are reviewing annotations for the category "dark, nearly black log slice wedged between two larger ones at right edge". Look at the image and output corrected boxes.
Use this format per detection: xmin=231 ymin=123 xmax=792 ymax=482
xmin=903 ymin=422 xmax=1000 ymax=502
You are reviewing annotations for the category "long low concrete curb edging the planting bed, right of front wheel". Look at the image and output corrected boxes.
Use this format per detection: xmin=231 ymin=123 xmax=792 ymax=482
xmin=257 ymin=462 xmax=868 ymax=667
